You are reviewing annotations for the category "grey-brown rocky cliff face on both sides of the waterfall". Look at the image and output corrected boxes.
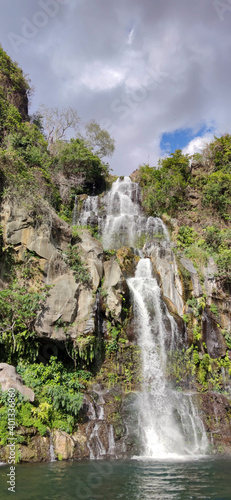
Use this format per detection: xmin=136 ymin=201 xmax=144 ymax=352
xmin=0 ymin=187 xmax=231 ymax=461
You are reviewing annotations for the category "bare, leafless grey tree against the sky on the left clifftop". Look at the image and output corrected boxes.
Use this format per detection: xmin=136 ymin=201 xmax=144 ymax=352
xmin=39 ymin=104 xmax=80 ymax=147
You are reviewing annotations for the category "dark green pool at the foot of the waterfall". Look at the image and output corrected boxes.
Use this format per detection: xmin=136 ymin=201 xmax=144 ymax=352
xmin=0 ymin=457 xmax=231 ymax=500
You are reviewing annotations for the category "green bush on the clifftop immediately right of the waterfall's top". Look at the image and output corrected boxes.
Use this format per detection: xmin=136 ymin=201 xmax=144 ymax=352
xmin=139 ymin=149 xmax=190 ymax=215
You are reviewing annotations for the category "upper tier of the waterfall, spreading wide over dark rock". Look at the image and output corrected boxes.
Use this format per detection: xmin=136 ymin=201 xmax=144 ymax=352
xmin=76 ymin=177 xmax=169 ymax=249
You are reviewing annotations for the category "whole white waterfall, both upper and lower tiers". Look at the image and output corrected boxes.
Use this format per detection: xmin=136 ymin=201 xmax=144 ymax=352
xmin=79 ymin=177 xmax=207 ymax=459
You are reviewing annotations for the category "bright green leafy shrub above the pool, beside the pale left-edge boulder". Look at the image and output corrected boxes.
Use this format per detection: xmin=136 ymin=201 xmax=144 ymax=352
xmin=17 ymin=357 xmax=86 ymax=434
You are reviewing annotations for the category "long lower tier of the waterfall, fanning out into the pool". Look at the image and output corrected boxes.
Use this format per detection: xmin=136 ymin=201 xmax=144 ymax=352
xmin=128 ymin=259 xmax=207 ymax=458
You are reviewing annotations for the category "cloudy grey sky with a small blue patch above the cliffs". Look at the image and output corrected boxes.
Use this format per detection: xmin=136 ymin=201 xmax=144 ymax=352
xmin=0 ymin=0 xmax=231 ymax=175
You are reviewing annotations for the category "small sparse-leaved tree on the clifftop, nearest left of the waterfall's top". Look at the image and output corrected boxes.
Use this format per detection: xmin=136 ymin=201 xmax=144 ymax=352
xmin=85 ymin=120 xmax=115 ymax=158
